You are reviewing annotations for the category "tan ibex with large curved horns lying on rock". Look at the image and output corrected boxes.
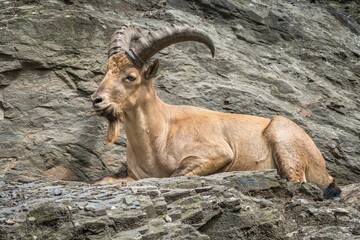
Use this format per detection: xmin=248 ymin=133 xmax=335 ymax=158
xmin=92 ymin=26 xmax=341 ymax=198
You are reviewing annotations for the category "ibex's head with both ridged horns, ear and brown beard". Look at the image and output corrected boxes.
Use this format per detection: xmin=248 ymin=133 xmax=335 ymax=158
xmin=91 ymin=26 xmax=215 ymax=143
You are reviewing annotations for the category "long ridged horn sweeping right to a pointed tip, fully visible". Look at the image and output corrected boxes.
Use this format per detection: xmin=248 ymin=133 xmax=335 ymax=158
xmin=126 ymin=26 xmax=215 ymax=67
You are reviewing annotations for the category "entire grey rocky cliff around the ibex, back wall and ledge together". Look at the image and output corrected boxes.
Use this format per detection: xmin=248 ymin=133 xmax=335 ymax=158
xmin=0 ymin=0 xmax=360 ymax=239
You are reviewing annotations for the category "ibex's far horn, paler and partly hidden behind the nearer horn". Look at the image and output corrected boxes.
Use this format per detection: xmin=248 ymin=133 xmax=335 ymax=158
xmin=108 ymin=25 xmax=142 ymax=58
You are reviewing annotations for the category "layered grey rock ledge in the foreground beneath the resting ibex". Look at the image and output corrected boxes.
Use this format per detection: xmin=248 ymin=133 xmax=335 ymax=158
xmin=0 ymin=170 xmax=360 ymax=240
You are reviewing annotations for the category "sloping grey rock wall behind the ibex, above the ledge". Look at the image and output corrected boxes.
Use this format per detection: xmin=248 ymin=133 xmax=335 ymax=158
xmin=0 ymin=0 xmax=360 ymax=184
